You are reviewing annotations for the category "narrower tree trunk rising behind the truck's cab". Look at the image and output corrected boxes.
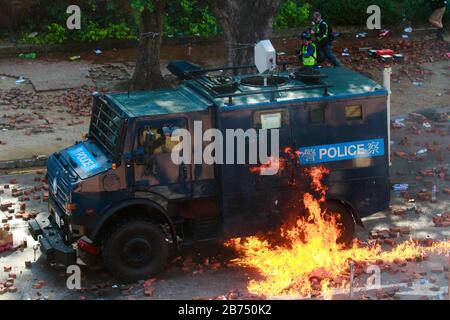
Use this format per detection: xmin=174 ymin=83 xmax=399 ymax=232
xmin=131 ymin=0 xmax=167 ymax=90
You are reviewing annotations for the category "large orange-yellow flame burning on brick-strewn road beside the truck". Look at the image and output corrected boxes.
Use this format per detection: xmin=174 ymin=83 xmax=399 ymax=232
xmin=226 ymin=167 xmax=450 ymax=297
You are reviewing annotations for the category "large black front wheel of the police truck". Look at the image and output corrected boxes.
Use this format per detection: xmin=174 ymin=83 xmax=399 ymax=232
xmin=103 ymin=220 xmax=169 ymax=281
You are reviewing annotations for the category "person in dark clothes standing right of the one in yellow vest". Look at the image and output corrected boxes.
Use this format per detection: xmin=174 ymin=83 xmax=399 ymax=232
xmin=311 ymin=11 xmax=341 ymax=67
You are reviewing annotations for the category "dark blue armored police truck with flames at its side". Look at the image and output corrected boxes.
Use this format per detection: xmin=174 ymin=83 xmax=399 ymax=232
xmin=29 ymin=62 xmax=390 ymax=280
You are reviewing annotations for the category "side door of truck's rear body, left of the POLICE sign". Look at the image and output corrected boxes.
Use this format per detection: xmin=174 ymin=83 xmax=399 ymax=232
xmin=229 ymin=108 xmax=293 ymax=235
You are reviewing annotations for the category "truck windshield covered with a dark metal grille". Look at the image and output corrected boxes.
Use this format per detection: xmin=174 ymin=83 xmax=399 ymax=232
xmin=89 ymin=98 xmax=124 ymax=157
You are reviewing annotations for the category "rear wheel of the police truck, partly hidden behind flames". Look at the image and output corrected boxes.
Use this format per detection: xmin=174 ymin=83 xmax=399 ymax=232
xmin=323 ymin=201 xmax=355 ymax=245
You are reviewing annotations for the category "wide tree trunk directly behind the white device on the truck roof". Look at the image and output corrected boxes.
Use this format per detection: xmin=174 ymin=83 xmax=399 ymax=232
xmin=206 ymin=0 xmax=281 ymax=73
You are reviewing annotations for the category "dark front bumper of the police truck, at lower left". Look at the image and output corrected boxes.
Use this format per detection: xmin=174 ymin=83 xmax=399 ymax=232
xmin=28 ymin=220 xmax=77 ymax=267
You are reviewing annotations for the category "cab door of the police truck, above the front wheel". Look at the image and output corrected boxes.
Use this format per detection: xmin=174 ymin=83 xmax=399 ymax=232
xmin=134 ymin=118 xmax=192 ymax=199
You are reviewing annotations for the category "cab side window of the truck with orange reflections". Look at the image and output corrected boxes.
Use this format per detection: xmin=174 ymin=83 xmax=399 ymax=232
xmin=137 ymin=123 xmax=185 ymax=154
